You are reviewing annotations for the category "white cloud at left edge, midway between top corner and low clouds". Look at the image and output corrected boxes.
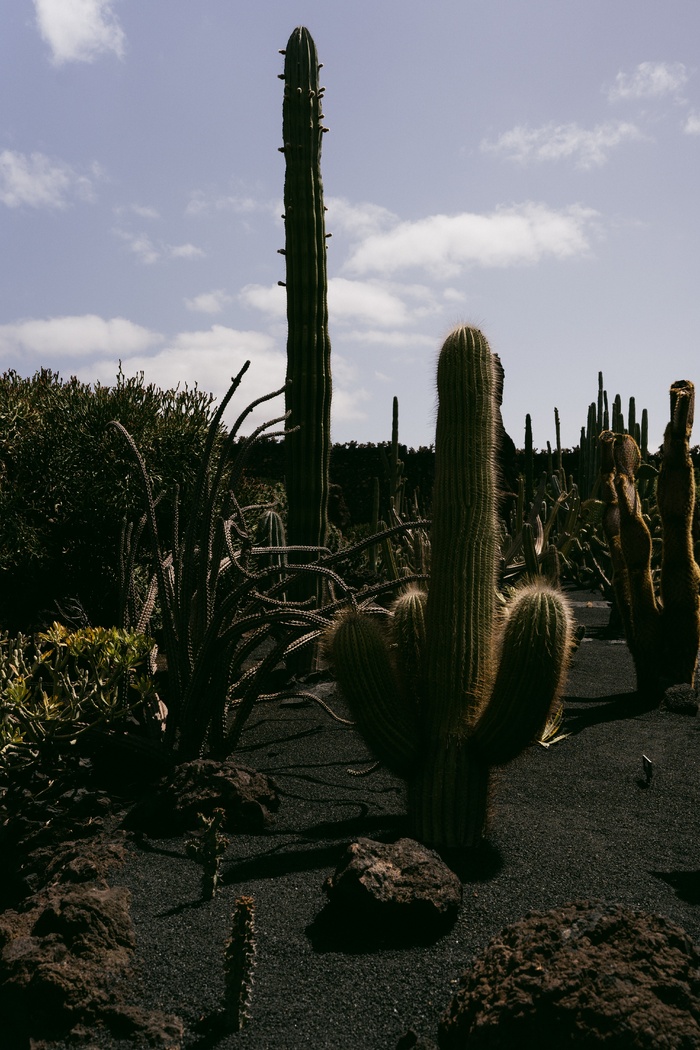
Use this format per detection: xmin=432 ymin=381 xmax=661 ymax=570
xmin=0 ymin=149 xmax=97 ymax=208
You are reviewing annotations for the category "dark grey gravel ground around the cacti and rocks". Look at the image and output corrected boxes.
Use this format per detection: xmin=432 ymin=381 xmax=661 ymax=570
xmin=42 ymin=593 xmax=700 ymax=1050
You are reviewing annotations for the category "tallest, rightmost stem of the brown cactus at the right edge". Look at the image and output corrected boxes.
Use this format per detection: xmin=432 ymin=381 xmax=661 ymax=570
xmin=657 ymin=380 xmax=700 ymax=685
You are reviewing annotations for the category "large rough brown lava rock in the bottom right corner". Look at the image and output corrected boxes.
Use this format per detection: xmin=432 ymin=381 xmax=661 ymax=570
xmin=438 ymin=901 xmax=700 ymax=1050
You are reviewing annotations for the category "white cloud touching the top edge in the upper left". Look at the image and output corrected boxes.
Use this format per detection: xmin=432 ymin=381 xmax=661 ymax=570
xmin=34 ymin=0 xmax=126 ymax=65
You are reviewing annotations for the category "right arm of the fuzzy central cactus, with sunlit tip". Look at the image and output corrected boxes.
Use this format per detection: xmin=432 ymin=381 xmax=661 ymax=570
xmin=470 ymin=583 xmax=573 ymax=765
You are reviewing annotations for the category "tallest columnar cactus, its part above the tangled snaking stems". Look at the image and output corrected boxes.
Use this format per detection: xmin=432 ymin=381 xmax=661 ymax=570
xmin=281 ymin=26 xmax=331 ymax=562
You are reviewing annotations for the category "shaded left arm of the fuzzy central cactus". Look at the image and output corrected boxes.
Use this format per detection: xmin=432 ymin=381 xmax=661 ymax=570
xmin=328 ymin=609 xmax=419 ymax=776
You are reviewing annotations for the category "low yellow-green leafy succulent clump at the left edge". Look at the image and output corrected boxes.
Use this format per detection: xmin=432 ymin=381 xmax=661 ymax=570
xmin=0 ymin=623 xmax=157 ymax=767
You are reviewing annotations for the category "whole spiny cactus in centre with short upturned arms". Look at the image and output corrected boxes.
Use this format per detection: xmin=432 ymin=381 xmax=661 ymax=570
xmin=328 ymin=328 xmax=572 ymax=849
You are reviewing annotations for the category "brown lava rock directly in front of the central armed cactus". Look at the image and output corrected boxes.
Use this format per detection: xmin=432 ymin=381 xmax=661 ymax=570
xmin=324 ymin=839 xmax=462 ymax=941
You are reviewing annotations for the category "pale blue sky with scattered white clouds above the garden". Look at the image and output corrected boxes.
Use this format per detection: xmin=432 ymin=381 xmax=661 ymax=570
xmin=0 ymin=0 xmax=700 ymax=447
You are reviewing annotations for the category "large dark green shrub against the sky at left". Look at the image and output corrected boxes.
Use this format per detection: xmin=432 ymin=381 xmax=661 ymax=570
xmin=0 ymin=369 xmax=221 ymax=633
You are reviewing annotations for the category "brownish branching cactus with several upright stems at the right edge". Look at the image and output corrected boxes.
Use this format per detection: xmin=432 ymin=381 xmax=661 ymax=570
xmin=600 ymin=380 xmax=700 ymax=696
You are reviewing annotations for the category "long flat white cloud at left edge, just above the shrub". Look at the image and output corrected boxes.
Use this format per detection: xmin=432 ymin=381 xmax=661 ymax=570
xmin=0 ymin=314 xmax=163 ymax=359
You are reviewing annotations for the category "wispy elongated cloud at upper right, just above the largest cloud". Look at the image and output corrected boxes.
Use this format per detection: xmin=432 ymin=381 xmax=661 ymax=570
xmin=481 ymin=122 xmax=644 ymax=169
